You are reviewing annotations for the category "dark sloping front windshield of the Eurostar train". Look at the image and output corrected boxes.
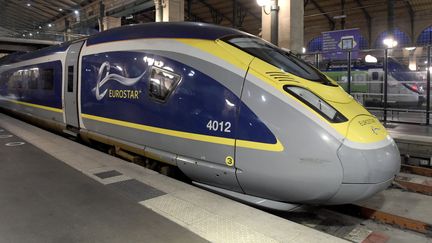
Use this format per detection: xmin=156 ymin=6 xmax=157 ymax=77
xmin=221 ymin=35 xmax=332 ymax=85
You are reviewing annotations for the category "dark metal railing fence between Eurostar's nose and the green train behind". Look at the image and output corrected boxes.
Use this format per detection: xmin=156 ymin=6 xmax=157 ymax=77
xmin=300 ymin=46 xmax=432 ymax=125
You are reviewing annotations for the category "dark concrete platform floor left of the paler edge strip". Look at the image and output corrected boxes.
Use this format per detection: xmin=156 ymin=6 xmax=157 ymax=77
xmin=0 ymin=128 xmax=206 ymax=242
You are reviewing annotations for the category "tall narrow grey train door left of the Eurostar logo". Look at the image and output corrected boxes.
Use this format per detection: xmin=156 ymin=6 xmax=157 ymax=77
xmin=63 ymin=42 xmax=83 ymax=128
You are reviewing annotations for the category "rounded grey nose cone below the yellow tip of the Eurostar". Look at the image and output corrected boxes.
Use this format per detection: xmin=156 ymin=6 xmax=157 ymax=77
xmin=327 ymin=136 xmax=400 ymax=204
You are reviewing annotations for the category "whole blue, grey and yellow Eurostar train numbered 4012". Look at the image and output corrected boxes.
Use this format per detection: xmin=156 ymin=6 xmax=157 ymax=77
xmin=0 ymin=23 xmax=400 ymax=210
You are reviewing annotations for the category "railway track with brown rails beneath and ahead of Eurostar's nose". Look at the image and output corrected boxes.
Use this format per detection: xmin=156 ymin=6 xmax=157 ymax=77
xmin=272 ymin=165 xmax=432 ymax=243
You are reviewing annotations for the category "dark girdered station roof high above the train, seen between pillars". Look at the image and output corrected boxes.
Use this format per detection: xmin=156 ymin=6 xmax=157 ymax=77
xmin=0 ymin=0 xmax=432 ymax=41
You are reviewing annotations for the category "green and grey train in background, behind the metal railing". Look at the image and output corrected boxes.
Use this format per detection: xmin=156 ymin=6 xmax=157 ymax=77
xmin=322 ymin=55 xmax=426 ymax=108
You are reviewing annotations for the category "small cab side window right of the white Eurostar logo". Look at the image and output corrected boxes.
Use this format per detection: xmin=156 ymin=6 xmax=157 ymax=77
xmin=148 ymin=67 xmax=181 ymax=102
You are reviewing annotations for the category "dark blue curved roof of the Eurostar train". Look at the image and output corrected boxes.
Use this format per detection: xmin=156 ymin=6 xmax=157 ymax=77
xmin=0 ymin=22 xmax=250 ymax=65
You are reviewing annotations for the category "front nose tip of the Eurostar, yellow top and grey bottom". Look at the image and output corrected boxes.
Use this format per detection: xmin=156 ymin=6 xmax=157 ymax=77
xmin=329 ymin=116 xmax=400 ymax=204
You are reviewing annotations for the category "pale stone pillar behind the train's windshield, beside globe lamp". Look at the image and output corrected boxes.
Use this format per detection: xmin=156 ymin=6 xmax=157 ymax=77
xmin=261 ymin=0 xmax=304 ymax=53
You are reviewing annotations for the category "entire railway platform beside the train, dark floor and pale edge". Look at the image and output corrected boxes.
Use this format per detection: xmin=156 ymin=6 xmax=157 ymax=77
xmin=0 ymin=113 xmax=344 ymax=243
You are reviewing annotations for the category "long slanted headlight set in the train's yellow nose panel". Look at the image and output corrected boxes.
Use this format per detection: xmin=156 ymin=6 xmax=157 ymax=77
xmin=284 ymin=85 xmax=348 ymax=123
